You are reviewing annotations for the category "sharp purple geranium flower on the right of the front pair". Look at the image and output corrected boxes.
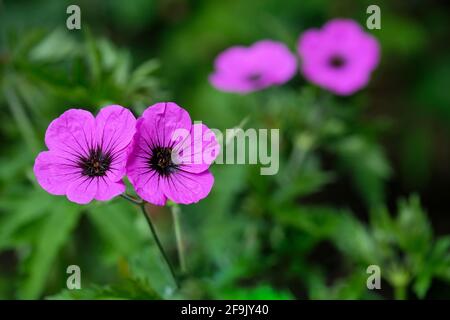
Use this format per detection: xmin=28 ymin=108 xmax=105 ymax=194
xmin=127 ymin=102 xmax=219 ymax=205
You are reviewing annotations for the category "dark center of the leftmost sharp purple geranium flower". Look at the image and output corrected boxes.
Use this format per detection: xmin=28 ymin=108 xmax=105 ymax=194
xmin=78 ymin=147 xmax=112 ymax=177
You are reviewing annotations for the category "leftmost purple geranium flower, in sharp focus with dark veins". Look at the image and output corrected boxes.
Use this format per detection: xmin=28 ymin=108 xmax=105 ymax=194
xmin=34 ymin=105 xmax=136 ymax=204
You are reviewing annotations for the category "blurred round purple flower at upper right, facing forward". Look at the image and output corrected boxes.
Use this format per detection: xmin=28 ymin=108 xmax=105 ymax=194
xmin=298 ymin=19 xmax=380 ymax=95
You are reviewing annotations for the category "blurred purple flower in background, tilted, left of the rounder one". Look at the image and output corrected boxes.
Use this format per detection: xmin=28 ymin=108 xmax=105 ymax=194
xmin=209 ymin=40 xmax=297 ymax=93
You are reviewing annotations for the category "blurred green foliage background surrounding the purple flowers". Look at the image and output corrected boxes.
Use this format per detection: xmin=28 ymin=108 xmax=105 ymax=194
xmin=0 ymin=0 xmax=450 ymax=299
